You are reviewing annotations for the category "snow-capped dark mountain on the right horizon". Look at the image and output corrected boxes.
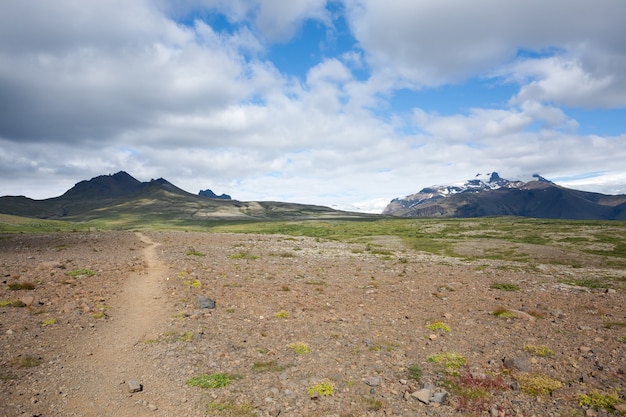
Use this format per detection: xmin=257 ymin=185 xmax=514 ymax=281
xmin=383 ymin=172 xmax=626 ymax=220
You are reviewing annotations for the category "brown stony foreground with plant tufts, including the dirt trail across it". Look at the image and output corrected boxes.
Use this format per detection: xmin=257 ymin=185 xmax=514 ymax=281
xmin=0 ymin=232 xmax=626 ymax=417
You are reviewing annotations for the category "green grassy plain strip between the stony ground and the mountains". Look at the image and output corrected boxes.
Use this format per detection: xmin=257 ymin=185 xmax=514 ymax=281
xmin=0 ymin=214 xmax=626 ymax=267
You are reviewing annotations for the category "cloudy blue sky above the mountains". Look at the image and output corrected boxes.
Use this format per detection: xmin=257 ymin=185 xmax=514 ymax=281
xmin=0 ymin=0 xmax=626 ymax=212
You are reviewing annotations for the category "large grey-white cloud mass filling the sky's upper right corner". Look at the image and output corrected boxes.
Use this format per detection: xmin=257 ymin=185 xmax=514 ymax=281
xmin=345 ymin=0 xmax=626 ymax=102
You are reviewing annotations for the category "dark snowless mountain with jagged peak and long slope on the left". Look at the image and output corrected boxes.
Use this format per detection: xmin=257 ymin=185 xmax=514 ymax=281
xmin=0 ymin=171 xmax=368 ymax=224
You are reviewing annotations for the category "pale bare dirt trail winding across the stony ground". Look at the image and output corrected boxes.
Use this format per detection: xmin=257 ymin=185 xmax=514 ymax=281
xmin=65 ymin=233 xmax=176 ymax=416
